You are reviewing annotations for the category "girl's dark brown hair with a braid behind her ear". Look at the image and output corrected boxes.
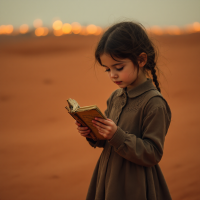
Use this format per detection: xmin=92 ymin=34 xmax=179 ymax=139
xmin=95 ymin=22 xmax=160 ymax=91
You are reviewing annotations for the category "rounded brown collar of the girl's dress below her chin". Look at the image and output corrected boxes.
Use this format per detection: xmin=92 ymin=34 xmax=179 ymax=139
xmin=117 ymin=78 xmax=157 ymax=98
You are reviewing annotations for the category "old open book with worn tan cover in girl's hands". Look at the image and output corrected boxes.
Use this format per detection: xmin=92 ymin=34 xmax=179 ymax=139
xmin=65 ymin=98 xmax=106 ymax=141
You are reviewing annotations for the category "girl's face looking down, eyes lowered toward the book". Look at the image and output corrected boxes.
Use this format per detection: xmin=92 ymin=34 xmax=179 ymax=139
xmin=100 ymin=54 xmax=146 ymax=90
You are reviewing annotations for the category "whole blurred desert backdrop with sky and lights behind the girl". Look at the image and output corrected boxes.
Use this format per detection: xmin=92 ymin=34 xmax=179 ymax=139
xmin=0 ymin=0 xmax=200 ymax=200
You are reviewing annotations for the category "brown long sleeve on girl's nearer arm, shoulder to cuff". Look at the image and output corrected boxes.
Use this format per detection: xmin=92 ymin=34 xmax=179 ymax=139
xmin=109 ymin=98 xmax=171 ymax=167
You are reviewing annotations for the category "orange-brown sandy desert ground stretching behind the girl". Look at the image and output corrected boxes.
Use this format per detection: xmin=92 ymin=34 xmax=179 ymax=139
xmin=0 ymin=33 xmax=200 ymax=200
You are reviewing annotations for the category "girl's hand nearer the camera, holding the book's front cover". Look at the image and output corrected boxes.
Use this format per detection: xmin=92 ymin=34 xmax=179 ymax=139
xmin=92 ymin=118 xmax=117 ymax=140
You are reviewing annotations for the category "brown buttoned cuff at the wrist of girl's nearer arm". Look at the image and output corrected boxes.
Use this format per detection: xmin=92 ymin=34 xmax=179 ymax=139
xmin=109 ymin=126 xmax=126 ymax=149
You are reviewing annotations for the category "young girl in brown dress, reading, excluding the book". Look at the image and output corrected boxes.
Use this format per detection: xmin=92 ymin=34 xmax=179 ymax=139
xmin=76 ymin=22 xmax=171 ymax=200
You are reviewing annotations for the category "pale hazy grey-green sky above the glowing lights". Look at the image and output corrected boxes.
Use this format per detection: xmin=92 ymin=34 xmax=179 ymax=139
xmin=0 ymin=0 xmax=200 ymax=27
